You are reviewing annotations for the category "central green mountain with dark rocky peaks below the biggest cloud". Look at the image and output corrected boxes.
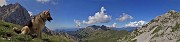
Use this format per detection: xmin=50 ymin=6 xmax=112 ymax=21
xmin=69 ymin=25 xmax=130 ymax=42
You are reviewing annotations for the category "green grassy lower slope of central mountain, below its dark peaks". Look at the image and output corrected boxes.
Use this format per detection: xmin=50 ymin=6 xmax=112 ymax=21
xmin=83 ymin=30 xmax=129 ymax=42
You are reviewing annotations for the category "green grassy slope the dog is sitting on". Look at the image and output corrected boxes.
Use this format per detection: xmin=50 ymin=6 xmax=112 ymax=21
xmin=0 ymin=21 xmax=74 ymax=42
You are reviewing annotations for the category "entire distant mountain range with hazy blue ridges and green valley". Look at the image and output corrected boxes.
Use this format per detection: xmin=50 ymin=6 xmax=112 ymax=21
xmin=58 ymin=25 xmax=132 ymax=42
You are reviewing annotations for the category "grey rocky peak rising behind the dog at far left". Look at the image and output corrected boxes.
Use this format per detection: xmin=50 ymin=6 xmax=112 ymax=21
xmin=0 ymin=3 xmax=31 ymax=25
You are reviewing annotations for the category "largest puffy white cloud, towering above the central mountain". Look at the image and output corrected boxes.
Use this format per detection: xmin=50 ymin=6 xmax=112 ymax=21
xmin=83 ymin=7 xmax=111 ymax=24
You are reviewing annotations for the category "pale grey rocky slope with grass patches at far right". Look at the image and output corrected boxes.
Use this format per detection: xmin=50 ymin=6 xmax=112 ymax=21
xmin=127 ymin=10 xmax=180 ymax=42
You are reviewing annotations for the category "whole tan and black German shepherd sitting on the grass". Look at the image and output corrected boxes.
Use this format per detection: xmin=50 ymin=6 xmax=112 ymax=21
xmin=14 ymin=10 xmax=53 ymax=38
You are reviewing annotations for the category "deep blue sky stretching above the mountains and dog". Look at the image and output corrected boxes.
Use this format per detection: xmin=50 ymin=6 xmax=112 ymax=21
xmin=2 ymin=0 xmax=180 ymax=29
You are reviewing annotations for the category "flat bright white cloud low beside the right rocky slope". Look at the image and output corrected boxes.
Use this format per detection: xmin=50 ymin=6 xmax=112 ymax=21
xmin=125 ymin=20 xmax=147 ymax=27
